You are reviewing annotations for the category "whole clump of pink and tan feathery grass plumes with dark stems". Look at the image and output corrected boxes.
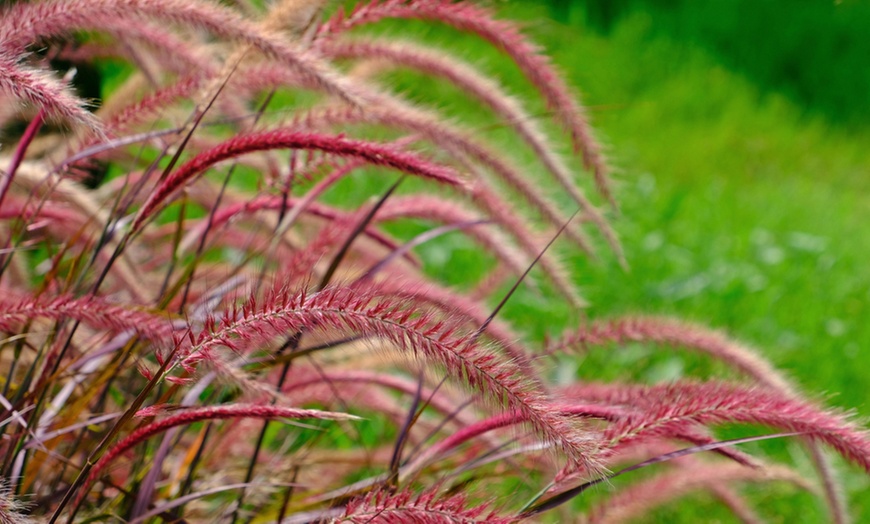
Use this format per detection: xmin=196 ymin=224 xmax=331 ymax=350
xmin=0 ymin=0 xmax=870 ymax=522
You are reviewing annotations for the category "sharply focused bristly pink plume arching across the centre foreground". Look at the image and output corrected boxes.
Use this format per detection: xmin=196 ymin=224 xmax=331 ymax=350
xmin=179 ymin=288 xmax=596 ymax=467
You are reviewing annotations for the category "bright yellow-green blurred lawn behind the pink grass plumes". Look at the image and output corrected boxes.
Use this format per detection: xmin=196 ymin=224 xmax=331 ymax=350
xmin=346 ymin=2 xmax=870 ymax=522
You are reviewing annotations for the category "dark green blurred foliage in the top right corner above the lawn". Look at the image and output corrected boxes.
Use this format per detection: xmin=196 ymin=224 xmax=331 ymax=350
xmin=548 ymin=0 xmax=870 ymax=124
